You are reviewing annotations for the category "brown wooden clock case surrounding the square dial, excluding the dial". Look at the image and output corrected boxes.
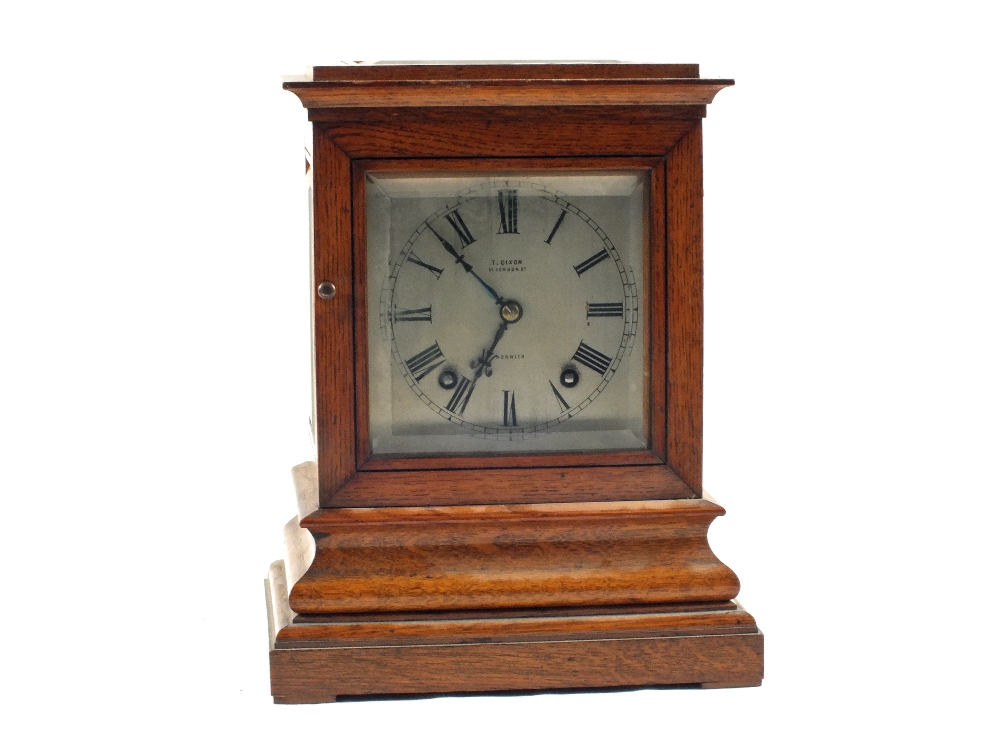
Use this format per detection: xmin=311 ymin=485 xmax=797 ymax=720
xmin=267 ymin=63 xmax=763 ymax=703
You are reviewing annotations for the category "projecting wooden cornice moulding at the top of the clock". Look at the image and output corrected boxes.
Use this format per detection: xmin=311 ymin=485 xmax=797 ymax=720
xmin=284 ymin=63 xmax=734 ymax=109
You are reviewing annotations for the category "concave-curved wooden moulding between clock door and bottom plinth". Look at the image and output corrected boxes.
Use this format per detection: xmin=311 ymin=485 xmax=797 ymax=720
xmin=289 ymin=499 xmax=739 ymax=614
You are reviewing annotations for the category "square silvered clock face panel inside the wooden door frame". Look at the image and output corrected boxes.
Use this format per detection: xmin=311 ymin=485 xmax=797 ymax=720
xmin=366 ymin=172 xmax=648 ymax=455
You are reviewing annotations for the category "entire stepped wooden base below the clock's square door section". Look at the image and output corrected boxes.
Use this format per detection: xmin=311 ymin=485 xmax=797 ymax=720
xmin=266 ymin=464 xmax=764 ymax=703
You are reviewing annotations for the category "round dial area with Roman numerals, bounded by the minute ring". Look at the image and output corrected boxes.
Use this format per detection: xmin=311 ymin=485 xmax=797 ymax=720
xmin=380 ymin=179 xmax=638 ymax=440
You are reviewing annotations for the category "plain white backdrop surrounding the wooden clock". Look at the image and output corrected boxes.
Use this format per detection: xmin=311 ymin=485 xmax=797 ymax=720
xmin=0 ymin=0 xmax=1000 ymax=748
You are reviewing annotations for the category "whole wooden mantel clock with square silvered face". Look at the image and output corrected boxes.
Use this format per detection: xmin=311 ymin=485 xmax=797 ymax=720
xmin=268 ymin=63 xmax=763 ymax=703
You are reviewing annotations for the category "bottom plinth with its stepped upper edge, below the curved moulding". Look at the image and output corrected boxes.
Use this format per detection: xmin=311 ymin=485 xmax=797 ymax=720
xmin=267 ymin=562 xmax=764 ymax=703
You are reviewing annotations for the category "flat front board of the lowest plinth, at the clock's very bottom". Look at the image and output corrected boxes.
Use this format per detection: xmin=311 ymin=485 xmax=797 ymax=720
xmin=270 ymin=632 xmax=764 ymax=703
